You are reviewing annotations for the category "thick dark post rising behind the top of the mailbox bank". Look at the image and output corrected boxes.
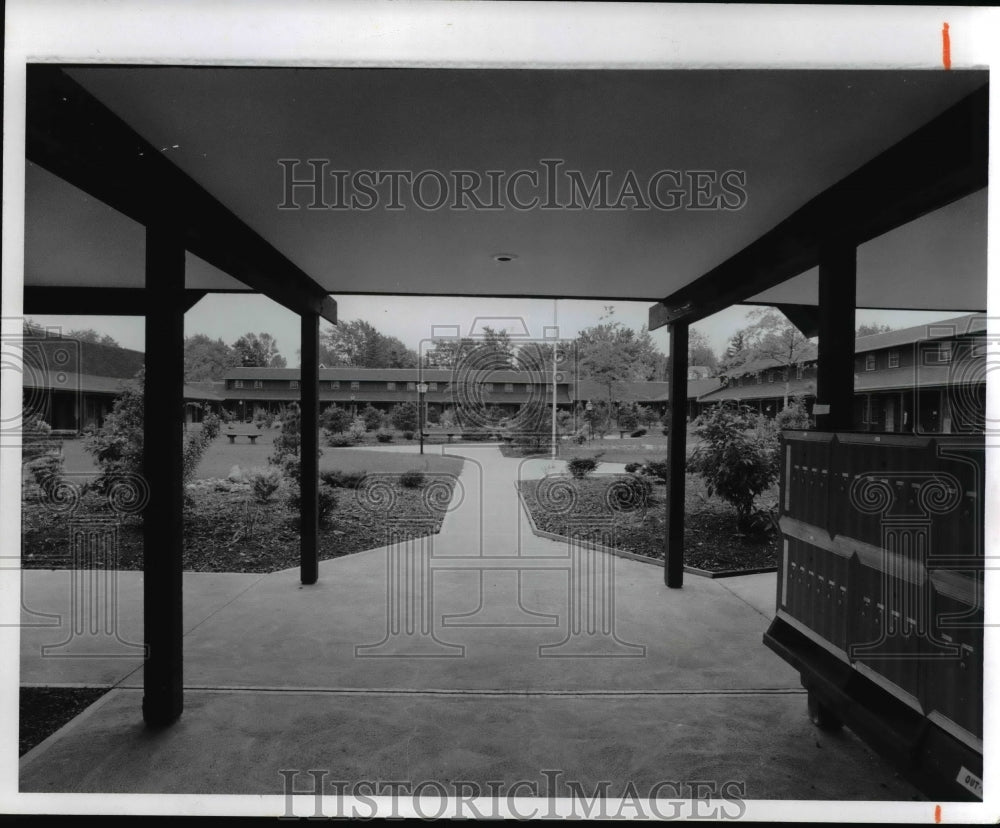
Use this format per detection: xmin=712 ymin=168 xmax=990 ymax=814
xmin=816 ymin=243 xmax=857 ymax=431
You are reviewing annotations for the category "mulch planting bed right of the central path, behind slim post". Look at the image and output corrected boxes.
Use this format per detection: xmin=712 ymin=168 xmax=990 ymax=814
xmin=519 ymin=474 xmax=778 ymax=572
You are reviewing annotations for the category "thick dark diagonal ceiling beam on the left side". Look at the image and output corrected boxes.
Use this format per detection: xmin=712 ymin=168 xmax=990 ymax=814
xmin=25 ymin=64 xmax=336 ymax=322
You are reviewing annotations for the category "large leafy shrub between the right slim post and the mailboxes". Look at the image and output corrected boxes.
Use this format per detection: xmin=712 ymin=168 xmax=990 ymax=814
xmin=688 ymin=406 xmax=778 ymax=531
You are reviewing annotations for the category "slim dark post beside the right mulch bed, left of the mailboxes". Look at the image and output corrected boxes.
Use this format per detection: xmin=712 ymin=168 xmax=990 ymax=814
xmin=663 ymin=322 xmax=688 ymax=589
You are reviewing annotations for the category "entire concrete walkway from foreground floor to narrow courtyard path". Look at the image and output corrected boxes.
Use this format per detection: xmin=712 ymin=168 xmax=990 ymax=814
xmin=21 ymin=445 xmax=917 ymax=800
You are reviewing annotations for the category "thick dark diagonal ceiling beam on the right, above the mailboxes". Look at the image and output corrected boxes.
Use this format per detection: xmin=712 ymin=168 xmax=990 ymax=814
xmin=649 ymin=85 xmax=989 ymax=330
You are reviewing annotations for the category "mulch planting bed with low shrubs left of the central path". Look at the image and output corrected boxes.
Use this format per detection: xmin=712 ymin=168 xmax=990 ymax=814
xmin=21 ymin=475 xmax=452 ymax=572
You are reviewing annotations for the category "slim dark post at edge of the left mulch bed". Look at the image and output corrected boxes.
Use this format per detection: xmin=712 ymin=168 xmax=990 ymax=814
xmin=299 ymin=313 xmax=319 ymax=584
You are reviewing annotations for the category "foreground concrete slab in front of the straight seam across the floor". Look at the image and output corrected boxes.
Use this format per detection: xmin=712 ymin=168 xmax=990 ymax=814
xmin=20 ymin=689 xmax=920 ymax=800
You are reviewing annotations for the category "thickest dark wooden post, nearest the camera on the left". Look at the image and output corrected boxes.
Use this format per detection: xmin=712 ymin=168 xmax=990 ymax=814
xmin=142 ymin=226 xmax=185 ymax=726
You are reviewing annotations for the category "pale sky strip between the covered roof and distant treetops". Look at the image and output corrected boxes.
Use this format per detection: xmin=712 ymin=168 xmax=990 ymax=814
xmin=32 ymin=294 xmax=958 ymax=366
